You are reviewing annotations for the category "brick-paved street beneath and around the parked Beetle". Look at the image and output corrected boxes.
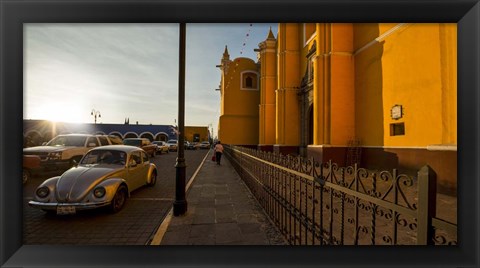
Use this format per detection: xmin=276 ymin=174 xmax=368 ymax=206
xmin=23 ymin=150 xmax=208 ymax=245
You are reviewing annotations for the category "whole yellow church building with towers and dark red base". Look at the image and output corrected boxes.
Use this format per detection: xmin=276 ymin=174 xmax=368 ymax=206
xmin=217 ymin=23 xmax=457 ymax=194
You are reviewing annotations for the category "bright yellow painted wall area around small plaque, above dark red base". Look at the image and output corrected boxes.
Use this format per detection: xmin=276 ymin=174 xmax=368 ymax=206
xmin=354 ymin=24 xmax=456 ymax=147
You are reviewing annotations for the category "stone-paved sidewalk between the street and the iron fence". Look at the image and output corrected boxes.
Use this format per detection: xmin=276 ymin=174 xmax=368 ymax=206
xmin=150 ymin=152 xmax=287 ymax=245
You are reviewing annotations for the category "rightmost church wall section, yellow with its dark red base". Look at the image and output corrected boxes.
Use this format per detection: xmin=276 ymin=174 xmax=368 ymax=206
xmin=355 ymin=24 xmax=457 ymax=194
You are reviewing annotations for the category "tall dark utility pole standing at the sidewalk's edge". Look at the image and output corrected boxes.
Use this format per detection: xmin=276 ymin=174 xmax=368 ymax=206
xmin=173 ymin=23 xmax=187 ymax=216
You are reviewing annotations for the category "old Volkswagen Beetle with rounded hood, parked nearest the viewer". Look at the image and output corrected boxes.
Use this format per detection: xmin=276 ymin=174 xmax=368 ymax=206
xmin=28 ymin=145 xmax=158 ymax=215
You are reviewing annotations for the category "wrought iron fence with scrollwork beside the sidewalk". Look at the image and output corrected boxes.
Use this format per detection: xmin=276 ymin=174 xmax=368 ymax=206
xmin=225 ymin=146 xmax=457 ymax=245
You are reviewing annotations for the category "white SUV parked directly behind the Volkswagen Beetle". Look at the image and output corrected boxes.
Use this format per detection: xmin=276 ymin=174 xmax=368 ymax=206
xmin=23 ymin=134 xmax=119 ymax=174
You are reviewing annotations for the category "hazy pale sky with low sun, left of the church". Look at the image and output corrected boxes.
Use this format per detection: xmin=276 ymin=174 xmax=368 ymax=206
xmin=23 ymin=23 xmax=277 ymax=135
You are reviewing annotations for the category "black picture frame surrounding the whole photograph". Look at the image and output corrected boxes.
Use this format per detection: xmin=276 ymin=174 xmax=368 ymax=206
xmin=0 ymin=0 xmax=480 ymax=267
